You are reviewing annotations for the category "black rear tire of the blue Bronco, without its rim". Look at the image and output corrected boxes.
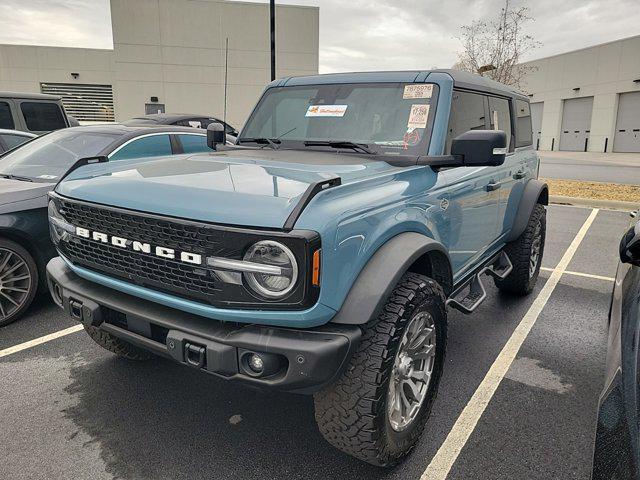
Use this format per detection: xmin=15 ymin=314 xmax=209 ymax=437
xmin=494 ymin=204 xmax=547 ymax=295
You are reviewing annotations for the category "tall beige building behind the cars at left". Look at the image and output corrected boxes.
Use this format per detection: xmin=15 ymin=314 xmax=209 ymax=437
xmin=0 ymin=0 xmax=318 ymax=127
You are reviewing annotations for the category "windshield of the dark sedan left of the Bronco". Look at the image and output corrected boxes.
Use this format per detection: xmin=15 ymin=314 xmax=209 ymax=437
xmin=0 ymin=128 xmax=120 ymax=182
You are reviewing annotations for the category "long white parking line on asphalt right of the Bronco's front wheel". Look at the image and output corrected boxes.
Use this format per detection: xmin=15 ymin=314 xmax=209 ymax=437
xmin=421 ymin=208 xmax=599 ymax=480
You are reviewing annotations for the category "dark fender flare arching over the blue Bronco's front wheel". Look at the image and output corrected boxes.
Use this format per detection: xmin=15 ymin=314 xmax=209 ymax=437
xmin=331 ymin=232 xmax=453 ymax=325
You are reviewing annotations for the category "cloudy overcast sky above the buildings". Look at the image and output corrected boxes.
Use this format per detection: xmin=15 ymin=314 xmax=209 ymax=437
xmin=0 ymin=0 xmax=640 ymax=73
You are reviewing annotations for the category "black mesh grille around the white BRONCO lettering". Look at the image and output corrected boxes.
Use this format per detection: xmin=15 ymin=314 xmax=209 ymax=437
xmin=54 ymin=197 xmax=318 ymax=308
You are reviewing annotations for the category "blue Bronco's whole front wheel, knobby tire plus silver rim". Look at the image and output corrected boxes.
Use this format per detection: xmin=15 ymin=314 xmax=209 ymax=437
xmin=314 ymin=273 xmax=447 ymax=466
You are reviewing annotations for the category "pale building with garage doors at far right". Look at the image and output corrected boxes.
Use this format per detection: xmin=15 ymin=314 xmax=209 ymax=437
xmin=524 ymin=35 xmax=640 ymax=152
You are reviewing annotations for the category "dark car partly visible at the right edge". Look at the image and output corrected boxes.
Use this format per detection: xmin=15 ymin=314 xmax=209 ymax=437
xmin=592 ymin=208 xmax=640 ymax=480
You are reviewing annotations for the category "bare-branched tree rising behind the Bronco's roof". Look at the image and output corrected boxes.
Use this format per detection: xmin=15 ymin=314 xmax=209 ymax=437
xmin=453 ymin=0 xmax=540 ymax=88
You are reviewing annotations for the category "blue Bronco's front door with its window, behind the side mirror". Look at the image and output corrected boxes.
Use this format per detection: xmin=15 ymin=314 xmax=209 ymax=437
xmin=441 ymin=91 xmax=500 ymax=274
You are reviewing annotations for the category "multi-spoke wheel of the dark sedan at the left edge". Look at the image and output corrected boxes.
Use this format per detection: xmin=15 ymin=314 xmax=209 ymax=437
xmin=0 ymin=238 xmax=38 ymax=327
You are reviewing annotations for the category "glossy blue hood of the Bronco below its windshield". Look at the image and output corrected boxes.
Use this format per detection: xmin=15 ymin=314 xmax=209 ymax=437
xmin=56 ymin=149 xmax=397 ymax=228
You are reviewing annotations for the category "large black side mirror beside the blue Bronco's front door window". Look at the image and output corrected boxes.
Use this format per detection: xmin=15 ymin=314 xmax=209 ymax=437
xmin=451 ymin=130 xmax=507 ymax=167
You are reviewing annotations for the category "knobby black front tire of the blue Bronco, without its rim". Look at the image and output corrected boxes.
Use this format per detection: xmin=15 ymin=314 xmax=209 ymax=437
xmin=314 ymin=273 xmax=447 ymax=466
